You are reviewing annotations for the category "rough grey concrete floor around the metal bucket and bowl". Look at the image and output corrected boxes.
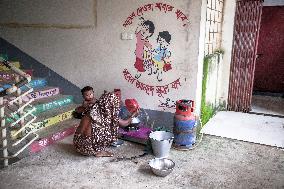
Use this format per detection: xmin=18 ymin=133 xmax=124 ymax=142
xmin=0 ymin=133 xmax=284 ymax=189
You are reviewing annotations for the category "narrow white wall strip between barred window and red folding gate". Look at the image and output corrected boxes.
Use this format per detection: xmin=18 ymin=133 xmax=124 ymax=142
xmin=202 ymin=0 xmax=236 ymax=107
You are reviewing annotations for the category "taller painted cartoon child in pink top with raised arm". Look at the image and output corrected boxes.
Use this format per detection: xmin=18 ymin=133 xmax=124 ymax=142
xmin=134 ymin=17 xmax=155 ymax=79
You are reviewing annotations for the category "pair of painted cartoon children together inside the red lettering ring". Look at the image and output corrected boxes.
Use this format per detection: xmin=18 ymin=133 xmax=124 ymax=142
xmin=134 ymin=17 xmax=172 ymax=81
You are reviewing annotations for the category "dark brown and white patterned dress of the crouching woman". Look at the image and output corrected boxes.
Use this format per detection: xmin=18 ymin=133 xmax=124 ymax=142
xmin=73 ymin=93 xmax=119 ymax=155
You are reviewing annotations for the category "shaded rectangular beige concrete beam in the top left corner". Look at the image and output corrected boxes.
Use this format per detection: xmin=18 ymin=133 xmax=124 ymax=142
xmin=0 ymin=0 xmax=95 ymax=26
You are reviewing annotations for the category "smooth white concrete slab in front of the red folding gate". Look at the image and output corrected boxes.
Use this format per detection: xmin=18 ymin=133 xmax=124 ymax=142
xmin=201 ymin=111 xmax=284 ymax=148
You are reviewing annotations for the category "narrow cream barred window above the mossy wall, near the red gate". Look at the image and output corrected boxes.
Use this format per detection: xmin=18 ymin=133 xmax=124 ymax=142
xmin=205 ymin=0 xmax=224 ymax=55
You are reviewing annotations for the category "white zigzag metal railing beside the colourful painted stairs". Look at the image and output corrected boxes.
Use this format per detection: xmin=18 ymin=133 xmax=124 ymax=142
xmin=0 ymin=57 xmax=38 ymax=167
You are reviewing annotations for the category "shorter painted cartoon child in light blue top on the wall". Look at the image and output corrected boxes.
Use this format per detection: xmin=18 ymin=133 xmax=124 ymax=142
xmin=153 ymin=31 xmax=172 ymax=81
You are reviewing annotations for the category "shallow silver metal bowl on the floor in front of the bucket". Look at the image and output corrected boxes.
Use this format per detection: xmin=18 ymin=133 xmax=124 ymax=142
xmin=149 ymin=158 xmax=175 ymax=177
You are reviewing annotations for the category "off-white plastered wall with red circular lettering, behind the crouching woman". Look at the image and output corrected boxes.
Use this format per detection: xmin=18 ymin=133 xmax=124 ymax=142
xmin=0 ymin=0 xmax=204 ymax=112
